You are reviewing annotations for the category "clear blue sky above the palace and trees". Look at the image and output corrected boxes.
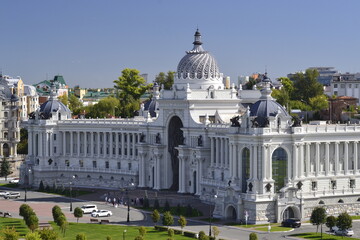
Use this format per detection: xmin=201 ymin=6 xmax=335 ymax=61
xmin=0 ymin=0 xmax=360 ymax=87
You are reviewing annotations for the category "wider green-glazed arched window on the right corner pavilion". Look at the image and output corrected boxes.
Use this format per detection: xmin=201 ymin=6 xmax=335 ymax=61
xmin=272 ymin=148 xmax=288 ymax=192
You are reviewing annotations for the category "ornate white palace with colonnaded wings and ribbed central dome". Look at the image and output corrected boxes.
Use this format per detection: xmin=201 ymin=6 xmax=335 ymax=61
xmin=22 ymin=31 xmax=360 ymax=223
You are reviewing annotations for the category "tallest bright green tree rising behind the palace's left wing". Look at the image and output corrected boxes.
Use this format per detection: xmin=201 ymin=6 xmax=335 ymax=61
xmin=114 ymin=68 xmax=151 ymax=117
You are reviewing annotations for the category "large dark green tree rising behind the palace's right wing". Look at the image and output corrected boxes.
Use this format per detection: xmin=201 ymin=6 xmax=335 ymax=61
xmin=291 ymin=69 xmax=324 ymax=104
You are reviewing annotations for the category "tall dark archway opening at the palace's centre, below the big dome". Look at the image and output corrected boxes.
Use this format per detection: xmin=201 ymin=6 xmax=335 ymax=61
xmin=168 ymin=116 xmax=184 ymax=191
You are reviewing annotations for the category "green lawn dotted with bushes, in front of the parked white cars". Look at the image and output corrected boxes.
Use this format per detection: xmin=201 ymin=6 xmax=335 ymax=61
xmin=52 ymin=223 xmax=193 ymax=240
